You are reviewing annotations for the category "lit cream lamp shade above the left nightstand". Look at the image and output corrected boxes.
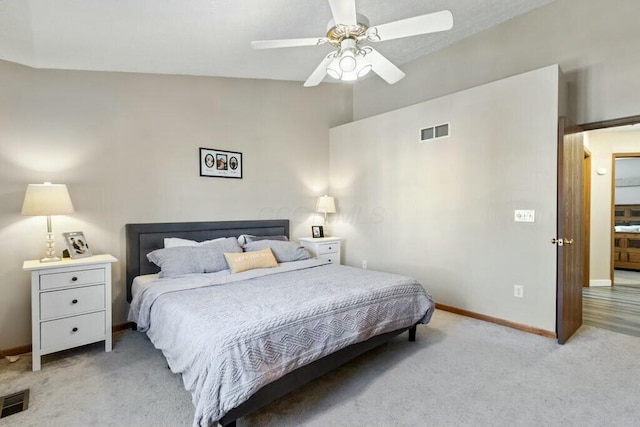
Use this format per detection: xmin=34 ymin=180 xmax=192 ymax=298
xmin=22 ymin=182 xmax=73 ymax=216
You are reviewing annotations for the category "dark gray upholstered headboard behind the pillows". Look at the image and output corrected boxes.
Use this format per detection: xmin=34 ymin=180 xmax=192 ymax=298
xmin=126 ymin=219 xmax=289 ymax=302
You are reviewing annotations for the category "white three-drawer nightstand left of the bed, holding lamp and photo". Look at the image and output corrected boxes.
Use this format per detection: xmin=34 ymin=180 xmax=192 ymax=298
xmin=22 ymin=255 xmax=118 ymax=371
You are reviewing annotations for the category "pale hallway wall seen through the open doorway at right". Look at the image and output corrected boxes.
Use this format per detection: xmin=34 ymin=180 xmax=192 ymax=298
xmin=587 ymin=130 xmax=640 ymax=286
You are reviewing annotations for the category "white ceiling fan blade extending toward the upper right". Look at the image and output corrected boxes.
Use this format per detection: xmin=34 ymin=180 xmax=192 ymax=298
xmin=369 ymin=10 xmax=453 ymax=41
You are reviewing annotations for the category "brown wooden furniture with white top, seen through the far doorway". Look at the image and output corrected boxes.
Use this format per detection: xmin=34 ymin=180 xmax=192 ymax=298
xmin=613 ymin=205 xmax=640 ymax=270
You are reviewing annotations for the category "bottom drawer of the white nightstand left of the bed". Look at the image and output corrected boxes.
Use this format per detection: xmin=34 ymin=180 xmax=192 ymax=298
xmin=40 ymin=311 xmax=105 ymax=352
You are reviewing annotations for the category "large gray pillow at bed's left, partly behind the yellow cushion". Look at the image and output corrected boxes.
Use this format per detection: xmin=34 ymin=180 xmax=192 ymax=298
xmin=147 ymin=237 xmax=242 ymax=277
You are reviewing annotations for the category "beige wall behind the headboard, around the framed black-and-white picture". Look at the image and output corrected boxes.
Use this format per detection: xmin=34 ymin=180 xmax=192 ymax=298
xmin=0 ymin=61 xmax=353 ymax=349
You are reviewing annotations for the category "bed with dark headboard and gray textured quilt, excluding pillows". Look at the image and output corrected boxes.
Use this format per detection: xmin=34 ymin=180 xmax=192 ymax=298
xmin=126 ymin=220 xmax=434 ymax=426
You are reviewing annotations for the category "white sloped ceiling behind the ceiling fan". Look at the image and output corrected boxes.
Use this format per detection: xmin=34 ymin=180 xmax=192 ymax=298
xmin=0 ymin=0 xmax=553 ymax=81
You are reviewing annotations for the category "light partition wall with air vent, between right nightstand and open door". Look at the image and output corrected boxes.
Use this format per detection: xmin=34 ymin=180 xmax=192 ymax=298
xmin=330 ymin=66 xmax=560 ymax=332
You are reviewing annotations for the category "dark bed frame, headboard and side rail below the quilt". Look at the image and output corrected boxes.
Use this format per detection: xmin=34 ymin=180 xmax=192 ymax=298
xmin=126 ymin=220 xmax=416 ymax=427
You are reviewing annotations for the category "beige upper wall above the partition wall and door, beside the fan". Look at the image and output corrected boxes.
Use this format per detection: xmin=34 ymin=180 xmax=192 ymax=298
xmin=354 ymin=0 xmax=640 ymax=123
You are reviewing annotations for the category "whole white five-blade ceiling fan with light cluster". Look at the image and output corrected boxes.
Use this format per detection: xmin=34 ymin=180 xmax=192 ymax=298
xmin=251 ymin=0 xmax=453 ymax=87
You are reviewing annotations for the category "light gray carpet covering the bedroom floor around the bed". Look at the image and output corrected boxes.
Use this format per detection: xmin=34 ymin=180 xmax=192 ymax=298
xmin=0 ymin=310 xmax=640 ymax=427
